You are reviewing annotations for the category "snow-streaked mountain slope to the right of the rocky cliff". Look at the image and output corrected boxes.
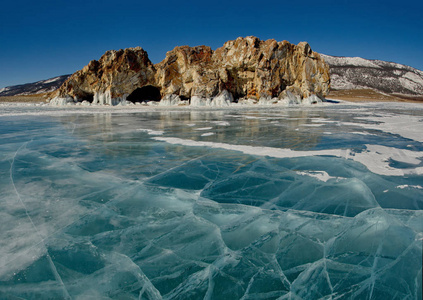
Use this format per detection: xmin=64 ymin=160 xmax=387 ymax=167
xmin=321 ymin=55 xmax=423 ymax=95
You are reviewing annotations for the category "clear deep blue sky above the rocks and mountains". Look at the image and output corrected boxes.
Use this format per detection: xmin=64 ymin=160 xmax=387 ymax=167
xmin=0 ymin=0 xmax=423 ymax=88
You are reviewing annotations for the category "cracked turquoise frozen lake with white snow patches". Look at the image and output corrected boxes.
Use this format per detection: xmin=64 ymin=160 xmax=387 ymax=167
xmin=0 ymin=103 xmax=423 ymax=299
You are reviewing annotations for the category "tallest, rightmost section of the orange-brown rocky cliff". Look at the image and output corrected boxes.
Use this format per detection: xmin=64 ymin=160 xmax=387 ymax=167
xmin=213 ymin=37 xmax=330 ymax=99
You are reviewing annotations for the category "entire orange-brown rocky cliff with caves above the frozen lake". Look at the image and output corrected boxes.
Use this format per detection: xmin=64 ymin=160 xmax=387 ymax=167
xmin=54 ymin=37 xmax=330 ymax=104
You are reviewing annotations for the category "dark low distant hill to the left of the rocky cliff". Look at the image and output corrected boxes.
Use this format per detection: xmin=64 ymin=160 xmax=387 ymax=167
xmin=0 ymin=75 xmax=70 ymax=96
